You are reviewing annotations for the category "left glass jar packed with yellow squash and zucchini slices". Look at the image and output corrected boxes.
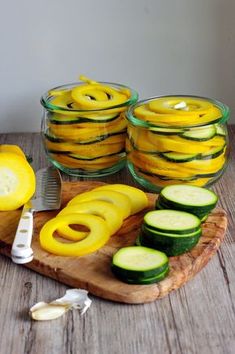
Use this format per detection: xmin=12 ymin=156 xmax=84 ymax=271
xmin=41 ymin=82 xmax=138 ymax=177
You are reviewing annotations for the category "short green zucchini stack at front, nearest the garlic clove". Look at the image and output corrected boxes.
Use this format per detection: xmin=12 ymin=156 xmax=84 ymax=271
xmin=111 ymin=246 xmax=169 ymax=280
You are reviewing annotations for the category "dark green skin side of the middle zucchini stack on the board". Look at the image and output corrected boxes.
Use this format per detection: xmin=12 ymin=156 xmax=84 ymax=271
xmin=139 ymin=229 xmax=202 ymax=257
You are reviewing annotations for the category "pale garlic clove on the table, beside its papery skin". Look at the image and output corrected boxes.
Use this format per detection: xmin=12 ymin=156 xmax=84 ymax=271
xmin=30 ymin=302 xmax=68 ymax=321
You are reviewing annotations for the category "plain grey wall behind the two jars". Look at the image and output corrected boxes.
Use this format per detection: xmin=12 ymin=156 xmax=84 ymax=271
xmin=0 ymin=0 xmax=235 ymax=133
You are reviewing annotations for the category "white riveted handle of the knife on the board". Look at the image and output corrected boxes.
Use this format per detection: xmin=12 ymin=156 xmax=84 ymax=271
xmin=11 ymin=208 xmax=33 ymax=264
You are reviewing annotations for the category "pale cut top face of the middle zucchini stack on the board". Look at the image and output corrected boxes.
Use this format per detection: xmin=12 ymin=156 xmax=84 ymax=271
xmin=144 ymin=209 xmax=201 ymax=234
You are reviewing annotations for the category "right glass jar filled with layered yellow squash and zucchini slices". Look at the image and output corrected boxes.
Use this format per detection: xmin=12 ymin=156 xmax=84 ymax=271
xmin=126 ymin=95 xmax=230 ymax=192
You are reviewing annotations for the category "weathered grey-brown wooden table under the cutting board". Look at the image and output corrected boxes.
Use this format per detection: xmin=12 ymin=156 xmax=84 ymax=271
xmin=0 ymin=126 xmax=235 ymax=354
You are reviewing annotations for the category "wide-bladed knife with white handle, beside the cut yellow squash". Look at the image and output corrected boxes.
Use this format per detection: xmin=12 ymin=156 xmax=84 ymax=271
xmin=11 ymin=167 xmax=62 ymax=264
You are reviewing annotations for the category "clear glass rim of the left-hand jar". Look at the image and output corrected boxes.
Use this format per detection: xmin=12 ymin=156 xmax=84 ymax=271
xmin=40 ymin=81 xmax=139 ymax=113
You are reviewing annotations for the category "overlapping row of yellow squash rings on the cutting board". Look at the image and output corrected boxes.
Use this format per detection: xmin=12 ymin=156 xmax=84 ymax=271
xmin=40 ymin=184 xmax=148 ymax=257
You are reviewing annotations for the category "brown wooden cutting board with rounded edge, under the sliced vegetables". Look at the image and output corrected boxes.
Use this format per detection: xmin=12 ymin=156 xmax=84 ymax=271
xmin=0 ymin=181 xmax=227 ymax=304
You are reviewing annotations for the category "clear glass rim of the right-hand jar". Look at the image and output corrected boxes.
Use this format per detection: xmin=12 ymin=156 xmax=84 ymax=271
xmin=125 ymin=94 xmax=230 ymax=130
